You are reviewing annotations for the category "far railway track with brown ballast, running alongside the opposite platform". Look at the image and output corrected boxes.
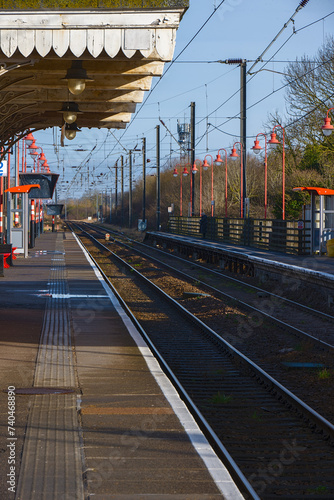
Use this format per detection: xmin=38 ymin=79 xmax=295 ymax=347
xmin=75 ymin=225 xmax=334 ymax=422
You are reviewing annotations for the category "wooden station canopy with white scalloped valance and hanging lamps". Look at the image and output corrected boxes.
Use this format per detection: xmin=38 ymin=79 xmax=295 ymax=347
xmin=0 ymin=0 xmax=189 ymax=147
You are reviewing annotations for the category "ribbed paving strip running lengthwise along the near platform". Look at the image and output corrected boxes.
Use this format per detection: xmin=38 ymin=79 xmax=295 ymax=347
xmin=15 ymin=234 xmax=84 ymax=500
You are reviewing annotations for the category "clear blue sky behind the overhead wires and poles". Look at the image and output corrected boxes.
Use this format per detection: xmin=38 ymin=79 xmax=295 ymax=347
xmin=35 ymin=0 xmax=334 ymax=196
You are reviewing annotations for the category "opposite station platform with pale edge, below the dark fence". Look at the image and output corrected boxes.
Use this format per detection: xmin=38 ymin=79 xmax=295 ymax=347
xmin=144 ymin=231 xmax=334 ymax=302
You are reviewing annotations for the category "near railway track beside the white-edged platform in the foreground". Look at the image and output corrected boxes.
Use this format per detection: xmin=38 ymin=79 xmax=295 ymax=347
xmin=69 ymin=224 xmax=334 ymax=499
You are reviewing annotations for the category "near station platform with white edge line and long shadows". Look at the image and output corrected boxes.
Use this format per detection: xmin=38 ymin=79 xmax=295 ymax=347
xmin=0 ymin=231 xmax=243 ymax=500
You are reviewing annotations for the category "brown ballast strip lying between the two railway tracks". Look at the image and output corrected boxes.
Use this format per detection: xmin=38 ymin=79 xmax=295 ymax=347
xmin=81 ymin=229 xmax=334 ymax=423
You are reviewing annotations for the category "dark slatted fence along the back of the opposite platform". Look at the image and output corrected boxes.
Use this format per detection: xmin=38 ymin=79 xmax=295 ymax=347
xmin=168 ymin=216 xmax=311 ymax=255
